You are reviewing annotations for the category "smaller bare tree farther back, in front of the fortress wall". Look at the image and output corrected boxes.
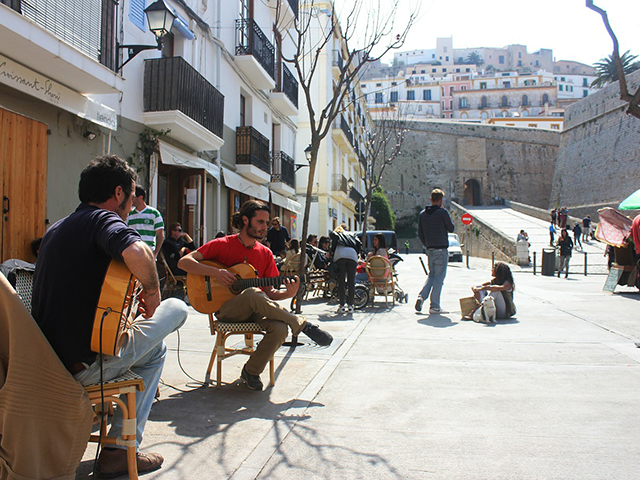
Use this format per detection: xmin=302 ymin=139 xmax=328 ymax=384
xmin=362 ymin=108 xmax=409 ymax=241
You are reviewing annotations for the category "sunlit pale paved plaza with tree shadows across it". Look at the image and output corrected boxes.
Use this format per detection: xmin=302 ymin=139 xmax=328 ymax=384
xmin=78 ymin=244 xmax=640 ymax=480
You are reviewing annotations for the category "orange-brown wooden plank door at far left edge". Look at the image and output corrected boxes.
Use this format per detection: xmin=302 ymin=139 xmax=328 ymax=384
xmin=0 ymin=109 xmax=47 ymax=262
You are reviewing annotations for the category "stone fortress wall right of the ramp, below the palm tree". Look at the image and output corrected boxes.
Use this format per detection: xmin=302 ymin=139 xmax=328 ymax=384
xmin=548 ymin=71 xmax=640 ymax=218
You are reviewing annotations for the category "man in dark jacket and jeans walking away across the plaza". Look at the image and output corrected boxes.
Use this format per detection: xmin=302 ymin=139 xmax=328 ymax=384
xmin=416 ymin=188 xmax=454 ymax=314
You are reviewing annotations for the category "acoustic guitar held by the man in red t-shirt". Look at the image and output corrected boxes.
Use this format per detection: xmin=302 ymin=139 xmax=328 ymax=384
xmin=187 ymin=260 xmax=294 ymax=313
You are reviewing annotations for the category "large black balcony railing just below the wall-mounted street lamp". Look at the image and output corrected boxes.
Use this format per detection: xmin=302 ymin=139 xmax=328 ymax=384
xmin=143 ymin=57 xmax=224 ymax=138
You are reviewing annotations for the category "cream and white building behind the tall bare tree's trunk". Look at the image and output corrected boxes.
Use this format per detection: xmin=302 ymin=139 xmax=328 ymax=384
xmin=296 ymin=1 xmax=372 ymax=235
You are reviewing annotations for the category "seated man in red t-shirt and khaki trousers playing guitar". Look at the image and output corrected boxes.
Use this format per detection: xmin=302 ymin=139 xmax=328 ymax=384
xmin=178 ymin=200 xmax=333 ymax=390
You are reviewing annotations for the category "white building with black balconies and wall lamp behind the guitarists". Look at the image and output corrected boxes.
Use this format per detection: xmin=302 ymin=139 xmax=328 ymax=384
xmin=0 ymin=0 xmax=300 ymax=259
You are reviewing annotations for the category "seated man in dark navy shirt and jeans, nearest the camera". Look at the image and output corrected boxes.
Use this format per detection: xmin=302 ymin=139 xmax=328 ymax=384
xmin=32 ymin=155 xmax=187 ymax=478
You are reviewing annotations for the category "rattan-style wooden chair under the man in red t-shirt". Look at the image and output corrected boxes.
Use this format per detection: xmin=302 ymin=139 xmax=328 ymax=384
xmin=204 ymin=313 xmax=276 ymax=387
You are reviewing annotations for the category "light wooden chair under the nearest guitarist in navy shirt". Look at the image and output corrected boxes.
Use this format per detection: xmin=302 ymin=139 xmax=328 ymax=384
xmin=16 ymin=270 xmax=144 ymax=480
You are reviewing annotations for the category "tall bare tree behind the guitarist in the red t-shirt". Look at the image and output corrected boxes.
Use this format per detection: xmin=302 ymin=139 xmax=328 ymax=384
xmin=282 ymin=0 xmax=417 ymax=311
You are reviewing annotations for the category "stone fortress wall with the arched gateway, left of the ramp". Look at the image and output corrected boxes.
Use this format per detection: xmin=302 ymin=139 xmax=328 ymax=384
xmin=382 ymin=121 xmax=560 ymax=225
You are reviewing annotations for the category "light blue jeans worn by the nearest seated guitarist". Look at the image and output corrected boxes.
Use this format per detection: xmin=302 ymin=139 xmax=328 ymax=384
xmin=73 ymin=298 xmax=188 ymax=448
